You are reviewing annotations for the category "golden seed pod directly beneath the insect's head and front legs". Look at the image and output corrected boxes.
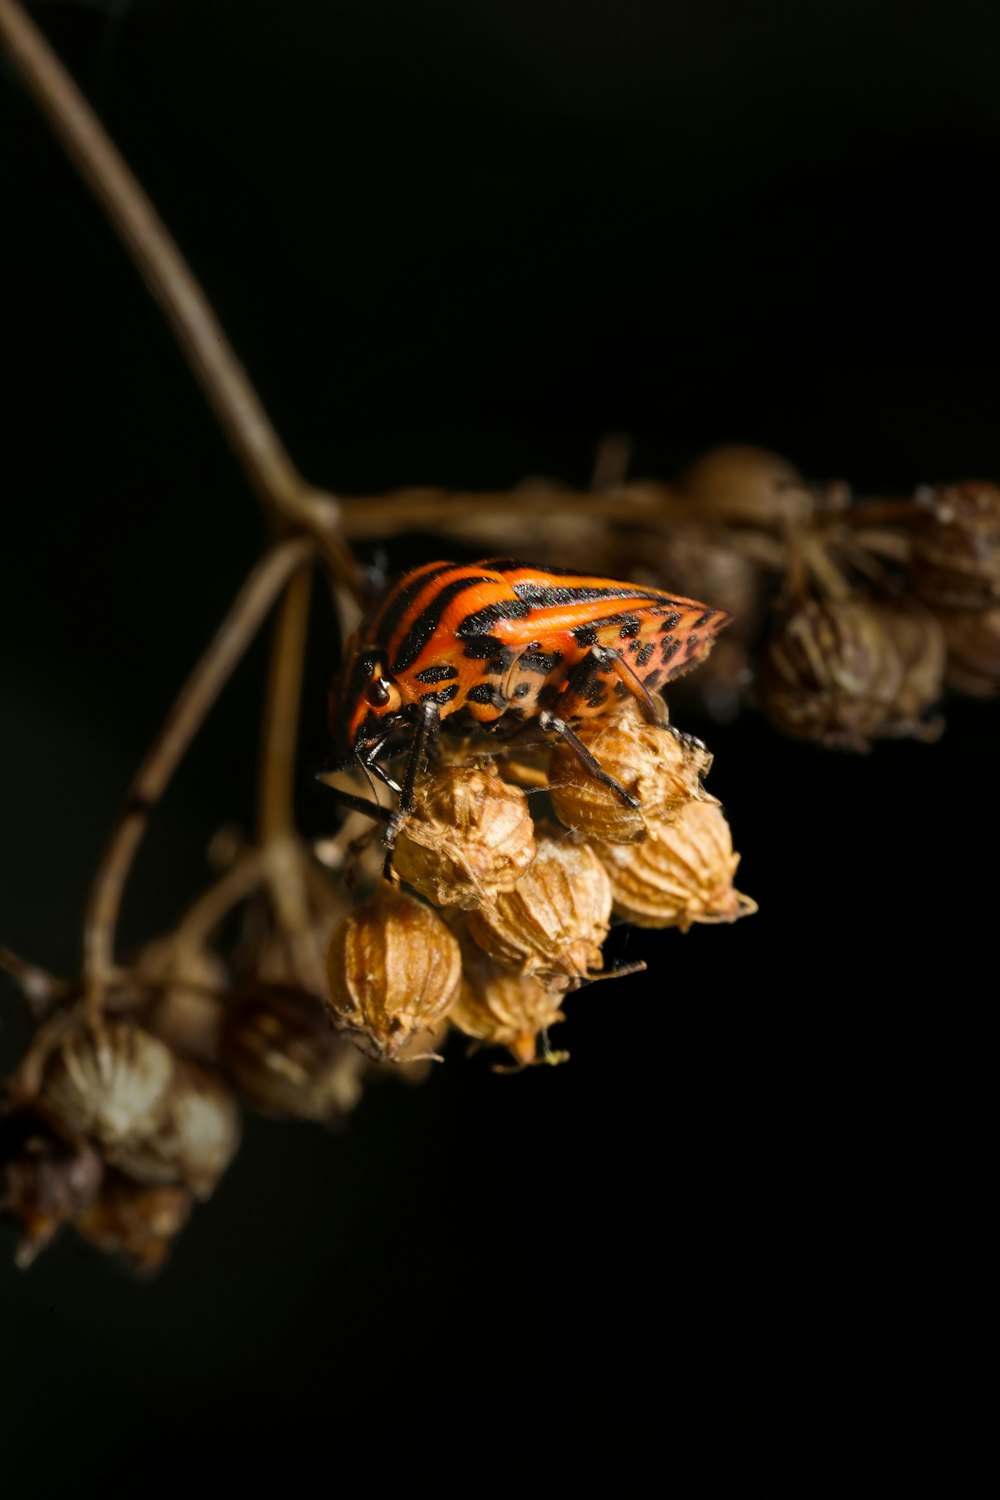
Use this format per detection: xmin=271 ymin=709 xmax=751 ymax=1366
xmin=393 ymin=762 xmax=535 ymax=909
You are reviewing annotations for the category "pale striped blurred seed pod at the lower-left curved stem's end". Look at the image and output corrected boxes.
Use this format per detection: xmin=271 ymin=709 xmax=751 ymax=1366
xmin=37 ymin=1020 xmax=175 ymax=1146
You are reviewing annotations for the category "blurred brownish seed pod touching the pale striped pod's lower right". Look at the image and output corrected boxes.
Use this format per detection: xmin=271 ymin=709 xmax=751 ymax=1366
xmin=106 ymin=1062 xmax=243 ymax=1199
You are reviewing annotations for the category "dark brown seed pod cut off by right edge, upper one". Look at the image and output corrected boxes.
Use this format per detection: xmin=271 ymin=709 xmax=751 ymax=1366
xmin=910 ymin=480 xmax=1000 ymax=609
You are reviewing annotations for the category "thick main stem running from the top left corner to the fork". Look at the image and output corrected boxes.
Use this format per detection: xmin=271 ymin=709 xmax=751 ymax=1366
xmin=0 ymin=0 xmax=361 ymax=599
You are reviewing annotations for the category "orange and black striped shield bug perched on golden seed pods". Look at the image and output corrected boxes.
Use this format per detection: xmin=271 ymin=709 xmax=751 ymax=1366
xmin=327 ymin=558 xmax=730 ymax=842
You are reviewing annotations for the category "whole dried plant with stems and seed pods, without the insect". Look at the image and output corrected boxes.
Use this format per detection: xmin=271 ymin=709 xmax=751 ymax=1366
xmin=0 ymin=0 xmax=1000 ymax=1274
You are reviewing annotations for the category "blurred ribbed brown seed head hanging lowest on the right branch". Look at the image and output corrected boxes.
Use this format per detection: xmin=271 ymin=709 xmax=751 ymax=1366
xmin=759 ymin=596 xmax=943 ymax=750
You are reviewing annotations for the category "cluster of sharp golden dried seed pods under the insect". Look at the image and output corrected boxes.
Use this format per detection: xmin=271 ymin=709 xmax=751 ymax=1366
xmin=327 ymin=705 xmax=756 ymax=1067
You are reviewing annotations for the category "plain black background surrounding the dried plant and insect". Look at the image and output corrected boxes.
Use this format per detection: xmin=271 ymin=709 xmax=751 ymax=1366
xmin=0 ymin=0 xmax=1000 ymax=1500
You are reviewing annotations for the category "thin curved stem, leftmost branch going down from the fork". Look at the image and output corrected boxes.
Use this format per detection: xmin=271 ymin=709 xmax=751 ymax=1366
xmin=84 ymin=537 xmax=315 ymax=1023
